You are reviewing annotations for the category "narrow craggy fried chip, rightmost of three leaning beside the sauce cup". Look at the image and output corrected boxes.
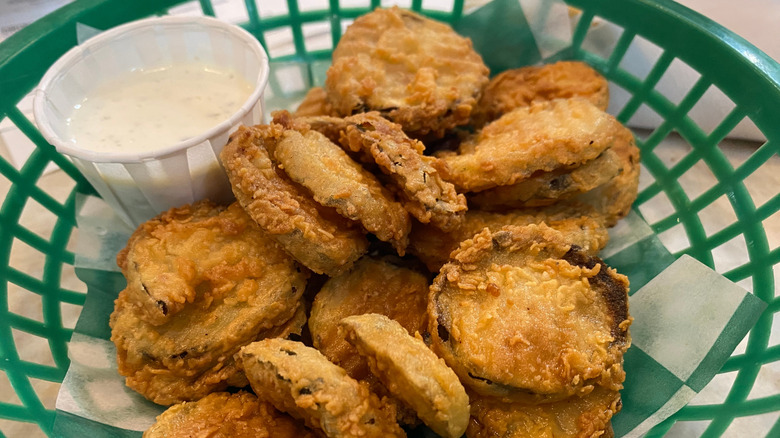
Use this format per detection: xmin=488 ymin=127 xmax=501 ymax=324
xmin=342 ymin=112 xmax=466 ymax=230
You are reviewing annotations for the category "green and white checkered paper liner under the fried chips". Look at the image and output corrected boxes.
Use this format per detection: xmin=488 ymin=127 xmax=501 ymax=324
xmin=54 ymin=0 xmax=766 ymax=437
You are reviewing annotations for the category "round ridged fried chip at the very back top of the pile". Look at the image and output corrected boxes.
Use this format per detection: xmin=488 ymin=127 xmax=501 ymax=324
xmin=325 ymin=8 xmax=488 ymax=137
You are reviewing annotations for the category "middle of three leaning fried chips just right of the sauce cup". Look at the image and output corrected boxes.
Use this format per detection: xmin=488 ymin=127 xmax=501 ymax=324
xmin=272 ymin=129 xmax=411 ymax=255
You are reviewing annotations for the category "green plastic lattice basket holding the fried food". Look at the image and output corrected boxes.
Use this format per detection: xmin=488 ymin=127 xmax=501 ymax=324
xmin=0 ymin=0 xmax=780 ymax=437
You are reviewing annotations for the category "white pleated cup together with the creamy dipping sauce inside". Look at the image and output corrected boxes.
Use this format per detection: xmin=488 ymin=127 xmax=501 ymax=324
xmin=33 ymin=17 xmax=269 ymax=227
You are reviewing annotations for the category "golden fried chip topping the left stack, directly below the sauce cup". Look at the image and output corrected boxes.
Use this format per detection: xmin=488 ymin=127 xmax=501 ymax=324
xmin=117 ymin=201 xmax=274 ymax=325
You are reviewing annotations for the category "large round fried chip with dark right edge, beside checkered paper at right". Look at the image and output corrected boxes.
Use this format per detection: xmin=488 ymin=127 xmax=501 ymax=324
xmin=428 ymin=224 xmax=631 ymax=402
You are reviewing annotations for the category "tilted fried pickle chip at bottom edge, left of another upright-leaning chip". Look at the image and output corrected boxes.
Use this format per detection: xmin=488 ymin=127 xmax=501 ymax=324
xmin=237 ymin=338 xmax=406 ymax=437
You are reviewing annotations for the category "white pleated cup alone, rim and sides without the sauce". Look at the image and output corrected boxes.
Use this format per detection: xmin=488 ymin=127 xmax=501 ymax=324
xmin=33 ymin=16 xmax=269 ymax=227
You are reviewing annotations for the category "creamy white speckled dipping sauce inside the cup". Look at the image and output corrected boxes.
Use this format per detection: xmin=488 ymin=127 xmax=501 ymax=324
xmin=67 ymin=63 xmax=253 ymax=152
